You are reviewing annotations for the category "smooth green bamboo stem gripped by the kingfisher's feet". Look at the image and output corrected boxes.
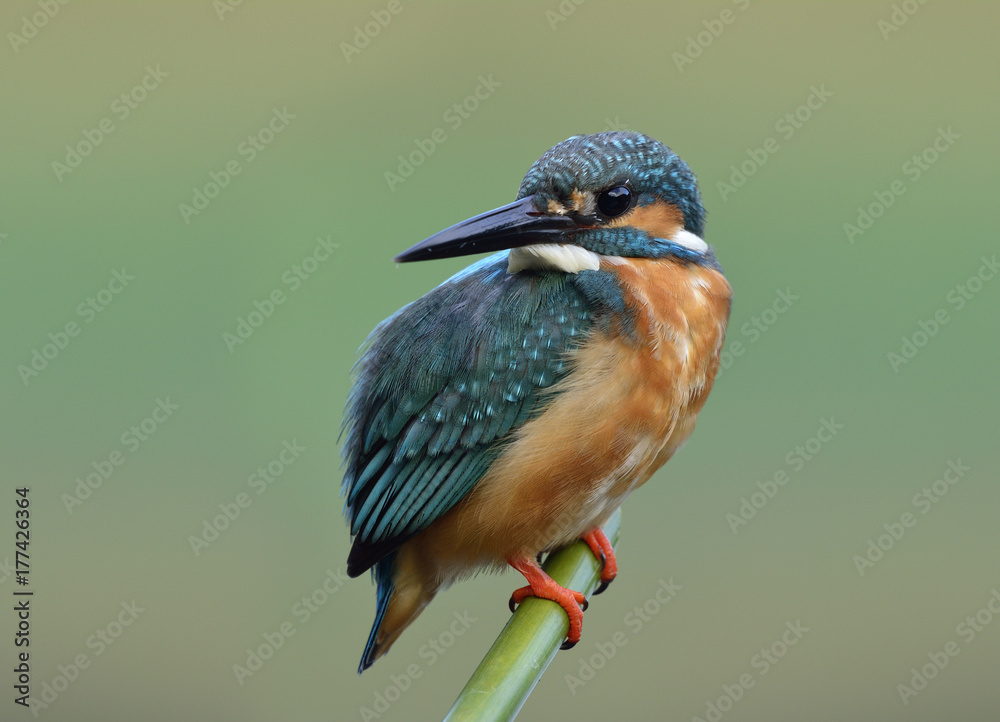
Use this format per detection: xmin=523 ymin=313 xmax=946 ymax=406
xmin=445 ymin=509 xmax=621 ymax=722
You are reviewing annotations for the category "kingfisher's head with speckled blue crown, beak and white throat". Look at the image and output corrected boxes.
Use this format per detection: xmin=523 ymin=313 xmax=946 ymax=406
xmin=396 ymin=132 xmax=715 ymax=272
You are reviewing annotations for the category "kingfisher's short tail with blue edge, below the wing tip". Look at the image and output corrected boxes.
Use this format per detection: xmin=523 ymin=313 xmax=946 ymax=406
xmin=358 ymin=546 xmax=437 ymax=674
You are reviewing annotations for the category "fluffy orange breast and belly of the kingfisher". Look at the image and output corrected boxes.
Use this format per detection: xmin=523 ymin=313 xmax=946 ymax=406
xmin=414 ymin=258 xmax=731 ymax=581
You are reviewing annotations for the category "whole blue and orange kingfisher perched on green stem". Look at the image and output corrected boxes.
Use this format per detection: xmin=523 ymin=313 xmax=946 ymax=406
xmin=342 ymin=131 xmax=732 ymax=674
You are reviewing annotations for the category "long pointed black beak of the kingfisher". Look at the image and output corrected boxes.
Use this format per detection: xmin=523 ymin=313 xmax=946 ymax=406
xmin=395 ymin=196 xmax=578 ymax=263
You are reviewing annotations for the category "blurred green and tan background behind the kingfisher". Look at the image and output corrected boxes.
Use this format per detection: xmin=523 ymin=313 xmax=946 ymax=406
xmin=0 ymin=0 xmax=1000 ymax=720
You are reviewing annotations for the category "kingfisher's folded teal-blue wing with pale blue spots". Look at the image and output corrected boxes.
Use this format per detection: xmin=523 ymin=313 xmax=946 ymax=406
xmin=344 ymin=252 xmax=594 ymax=576
